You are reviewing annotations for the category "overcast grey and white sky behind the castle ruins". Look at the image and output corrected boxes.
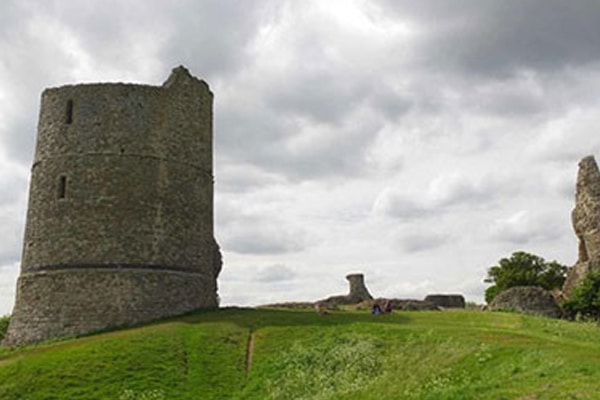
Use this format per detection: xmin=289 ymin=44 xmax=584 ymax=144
xmin=0 ymin=0 xmax=600 ymax=314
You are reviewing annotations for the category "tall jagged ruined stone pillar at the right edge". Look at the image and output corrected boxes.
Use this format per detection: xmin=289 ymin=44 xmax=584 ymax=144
xmin=563 ymin=156 xmax=600 ymax=298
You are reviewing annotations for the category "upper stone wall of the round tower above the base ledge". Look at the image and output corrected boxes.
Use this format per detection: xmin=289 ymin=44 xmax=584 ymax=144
xmin=22 ymin=72 xmax=213 ymax=272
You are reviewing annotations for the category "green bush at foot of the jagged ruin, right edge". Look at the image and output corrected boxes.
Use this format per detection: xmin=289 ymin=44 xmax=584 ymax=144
xmin=562 ymin=272 xmax=600 ymax=321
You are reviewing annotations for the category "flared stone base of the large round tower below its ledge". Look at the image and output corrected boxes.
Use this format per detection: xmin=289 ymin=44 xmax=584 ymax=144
xmin=2 ymin=266 xmax=218 ymax=346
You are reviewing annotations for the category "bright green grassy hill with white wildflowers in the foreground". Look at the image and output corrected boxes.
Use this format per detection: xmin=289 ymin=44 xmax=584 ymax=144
xmin=0 ymin=309 xmax=600 ymax=400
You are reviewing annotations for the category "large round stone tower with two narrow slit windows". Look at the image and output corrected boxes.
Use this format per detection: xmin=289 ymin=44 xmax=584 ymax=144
xmin=5 ymin=67 xmax=220 ymax=345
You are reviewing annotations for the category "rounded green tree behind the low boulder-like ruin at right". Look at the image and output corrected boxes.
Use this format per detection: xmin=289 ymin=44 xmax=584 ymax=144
xmin=484 ymin=251 xmax=568 ymax=303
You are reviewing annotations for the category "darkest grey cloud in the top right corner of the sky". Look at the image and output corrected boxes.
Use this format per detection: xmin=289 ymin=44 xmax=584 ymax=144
xmin=381 ymin=0 xmax=600 ymax=77
